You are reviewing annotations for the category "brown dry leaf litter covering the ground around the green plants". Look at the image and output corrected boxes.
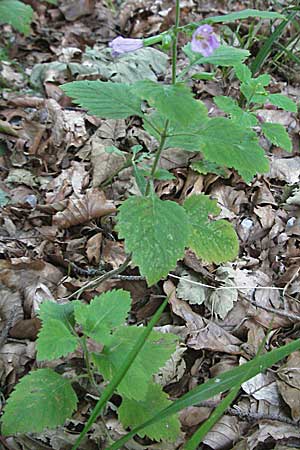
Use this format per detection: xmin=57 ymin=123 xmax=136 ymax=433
xmin=0 ymin=0 xmax=300 ymax=450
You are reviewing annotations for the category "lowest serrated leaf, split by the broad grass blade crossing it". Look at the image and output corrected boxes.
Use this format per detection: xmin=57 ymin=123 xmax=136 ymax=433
xmin=118 ymin=383 xmax=180 ymax=442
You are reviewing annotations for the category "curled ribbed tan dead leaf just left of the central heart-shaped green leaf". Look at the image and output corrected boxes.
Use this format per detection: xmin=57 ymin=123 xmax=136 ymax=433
xmin=53 ymin=189 xmax=116 ymax=228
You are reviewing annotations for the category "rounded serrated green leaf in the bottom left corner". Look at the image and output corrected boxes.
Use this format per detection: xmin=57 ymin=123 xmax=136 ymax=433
xmin=1 ymin=369 xmax=77 ymax=435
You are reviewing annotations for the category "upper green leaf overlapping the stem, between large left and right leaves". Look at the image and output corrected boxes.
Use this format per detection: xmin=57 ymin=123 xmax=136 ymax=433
xmin=133 ymin=80 xmax=206 ymax=125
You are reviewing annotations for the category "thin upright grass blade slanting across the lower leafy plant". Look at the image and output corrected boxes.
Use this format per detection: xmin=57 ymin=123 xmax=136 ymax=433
xmin=72 ymin=296 xmax=169 ymax=450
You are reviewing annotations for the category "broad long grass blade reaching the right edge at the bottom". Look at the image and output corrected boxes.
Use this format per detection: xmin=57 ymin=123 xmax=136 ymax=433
xmin=109 ymin=339 xmax=300 ymax=450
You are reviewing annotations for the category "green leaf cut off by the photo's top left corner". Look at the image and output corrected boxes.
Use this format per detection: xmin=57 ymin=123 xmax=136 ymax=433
xmin=0 ymin=0 xmax=33 ymax=35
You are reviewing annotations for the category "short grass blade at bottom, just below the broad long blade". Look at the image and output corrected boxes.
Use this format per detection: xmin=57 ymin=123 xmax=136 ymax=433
xmin=183 ymin=386 xmax=240 ymax=450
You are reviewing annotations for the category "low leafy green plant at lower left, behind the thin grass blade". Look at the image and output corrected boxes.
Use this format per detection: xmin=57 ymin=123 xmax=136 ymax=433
xmin=2 ymin=290 xmax=179 ymax=440
